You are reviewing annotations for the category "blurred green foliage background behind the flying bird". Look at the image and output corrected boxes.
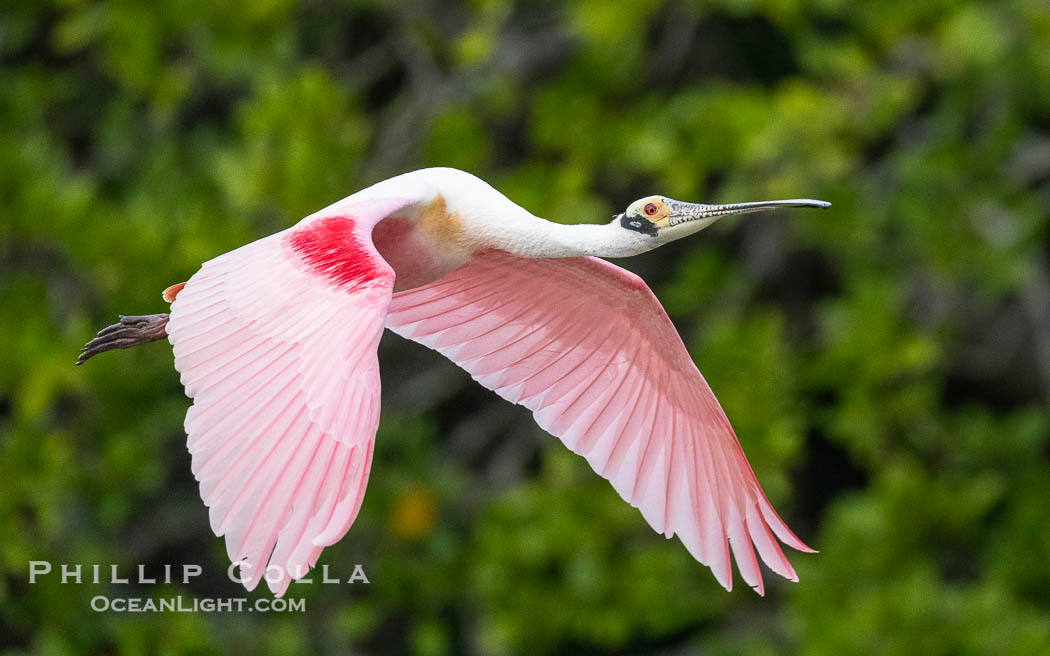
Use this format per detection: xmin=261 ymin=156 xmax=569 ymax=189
xmin=0 ymin=0 xmax=1050 ymax=656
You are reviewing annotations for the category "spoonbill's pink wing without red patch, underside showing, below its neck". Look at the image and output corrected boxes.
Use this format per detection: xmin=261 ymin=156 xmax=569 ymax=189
xmin=386 ymin=252 xmax=812 ymax=594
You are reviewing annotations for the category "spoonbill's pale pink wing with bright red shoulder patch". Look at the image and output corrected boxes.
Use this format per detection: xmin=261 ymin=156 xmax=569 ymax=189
xmin=168 ymin=194 xmax=410 ymax=595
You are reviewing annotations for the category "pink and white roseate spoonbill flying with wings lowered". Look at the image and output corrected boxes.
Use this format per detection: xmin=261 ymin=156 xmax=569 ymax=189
xmin=78 ymin=168 xmax=830 ymax=595
